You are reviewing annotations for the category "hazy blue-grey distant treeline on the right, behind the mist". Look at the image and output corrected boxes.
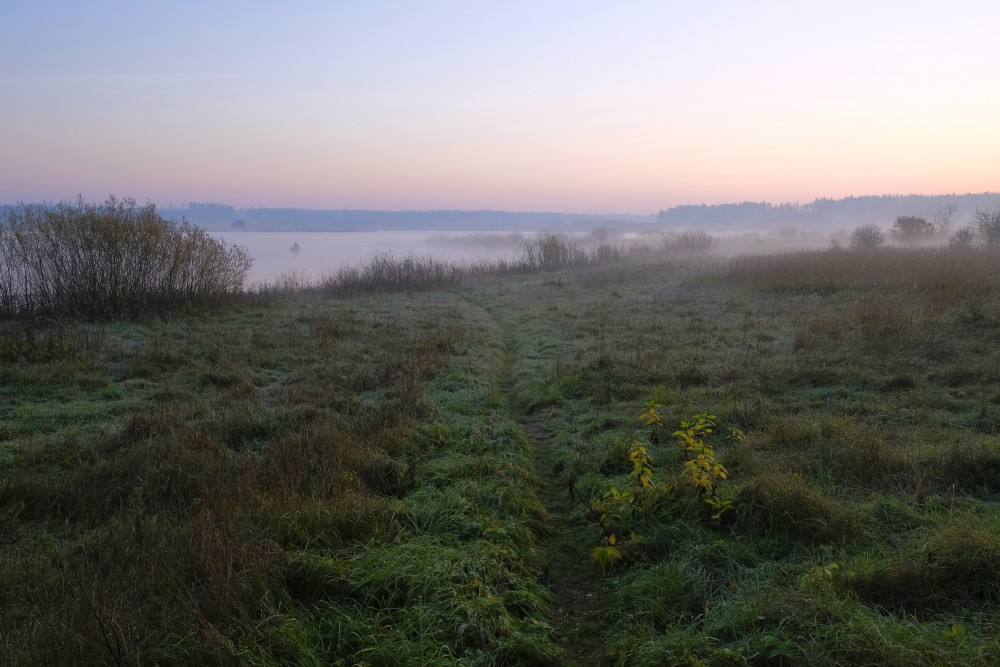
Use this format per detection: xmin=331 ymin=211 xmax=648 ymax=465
xmin=657 ymin=192 xmax=1000 ymax=230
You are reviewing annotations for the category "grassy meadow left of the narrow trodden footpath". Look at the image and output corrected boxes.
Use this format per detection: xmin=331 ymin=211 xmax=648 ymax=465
xmin=0 ymin=294 xmax=560 ymax=665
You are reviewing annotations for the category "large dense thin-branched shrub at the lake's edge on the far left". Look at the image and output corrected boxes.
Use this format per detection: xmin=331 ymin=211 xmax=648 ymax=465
xmin=0 ymin=197 xmax=253 ymax=317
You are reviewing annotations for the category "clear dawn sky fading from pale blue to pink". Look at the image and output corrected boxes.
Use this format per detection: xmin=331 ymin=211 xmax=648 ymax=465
xmin=0 ymin=0 xmax=1000 ymax=214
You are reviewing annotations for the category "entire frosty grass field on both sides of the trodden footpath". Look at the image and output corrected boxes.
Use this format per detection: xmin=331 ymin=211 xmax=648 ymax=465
xmin=0 ymin=248 xmax=1000 ymax=667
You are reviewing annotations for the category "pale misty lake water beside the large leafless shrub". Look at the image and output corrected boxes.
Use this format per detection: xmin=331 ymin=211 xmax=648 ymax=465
xmin=212 ymin=231 xmax=526 ymax=283
